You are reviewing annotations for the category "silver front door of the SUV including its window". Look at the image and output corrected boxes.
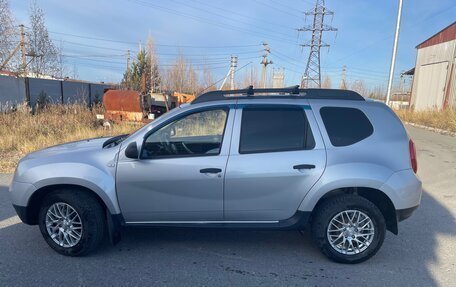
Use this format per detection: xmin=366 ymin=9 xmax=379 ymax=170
xmin=116 ymin=106 xmax=234 ymax=223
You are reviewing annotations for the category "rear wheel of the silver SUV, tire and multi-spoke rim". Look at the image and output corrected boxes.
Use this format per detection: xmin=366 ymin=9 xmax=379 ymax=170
xmin=311 ymin=194 xmax=386 ymax=264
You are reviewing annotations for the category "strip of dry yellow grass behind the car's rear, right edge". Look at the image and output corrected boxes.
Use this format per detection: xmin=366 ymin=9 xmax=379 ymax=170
xmin=395 ymin=109 xmax=456 ymax=132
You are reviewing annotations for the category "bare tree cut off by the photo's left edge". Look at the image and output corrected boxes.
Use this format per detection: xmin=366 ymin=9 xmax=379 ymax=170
xmin=0 ymin=0 xmax=19 ymax=71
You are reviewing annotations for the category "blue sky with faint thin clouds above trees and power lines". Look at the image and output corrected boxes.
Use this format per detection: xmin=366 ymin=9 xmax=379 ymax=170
xmin=10 ymin=0 xmax=456 ymax=86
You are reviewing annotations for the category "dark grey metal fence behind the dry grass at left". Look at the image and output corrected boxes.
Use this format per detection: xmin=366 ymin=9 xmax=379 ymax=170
xmin=0 ymin=75 xmax=114 ymax=111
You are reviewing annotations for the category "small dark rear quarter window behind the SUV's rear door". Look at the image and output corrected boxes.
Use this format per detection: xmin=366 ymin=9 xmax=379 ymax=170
xmin=320 ymin=107 xmax=374 ymax=147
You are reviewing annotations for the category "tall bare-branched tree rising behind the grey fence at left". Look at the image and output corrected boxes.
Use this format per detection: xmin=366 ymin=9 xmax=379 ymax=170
xmin=26 ymin=2 xmax=62 ymax=76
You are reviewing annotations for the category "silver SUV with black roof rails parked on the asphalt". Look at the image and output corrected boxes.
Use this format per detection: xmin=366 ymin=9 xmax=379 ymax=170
xmin=10 ymin=87 xmax=421 ymax=263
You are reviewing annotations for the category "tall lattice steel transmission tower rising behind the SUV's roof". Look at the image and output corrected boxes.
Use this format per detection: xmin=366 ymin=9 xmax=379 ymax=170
xmin=298 ymin=0 xmax=337 ymax=88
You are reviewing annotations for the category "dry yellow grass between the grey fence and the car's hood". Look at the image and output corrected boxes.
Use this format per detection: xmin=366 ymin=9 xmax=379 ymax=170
xmin=0 ymin=105 xmax=139 ymax=172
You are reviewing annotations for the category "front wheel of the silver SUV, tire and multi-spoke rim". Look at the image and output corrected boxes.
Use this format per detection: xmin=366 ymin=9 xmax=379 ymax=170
xmin=39 ymin=190 xmax=106 ymax=256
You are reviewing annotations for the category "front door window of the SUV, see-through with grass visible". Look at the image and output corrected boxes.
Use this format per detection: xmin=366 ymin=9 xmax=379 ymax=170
xmin=141 ymin=109 xmax=228 ymax=159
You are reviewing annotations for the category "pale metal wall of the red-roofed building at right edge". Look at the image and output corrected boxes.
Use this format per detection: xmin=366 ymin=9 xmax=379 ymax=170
xmin=411 ymin=40 xmax=456 ymax=110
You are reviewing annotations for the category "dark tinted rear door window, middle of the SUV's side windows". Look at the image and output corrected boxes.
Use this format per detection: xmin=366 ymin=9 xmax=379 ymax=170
xmin=239 ymin=107 xmax=315 ymax=154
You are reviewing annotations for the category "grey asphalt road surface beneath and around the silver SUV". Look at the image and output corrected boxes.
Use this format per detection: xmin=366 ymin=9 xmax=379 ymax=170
xmin=0 ymin=127 xmax=456 ymax=286
